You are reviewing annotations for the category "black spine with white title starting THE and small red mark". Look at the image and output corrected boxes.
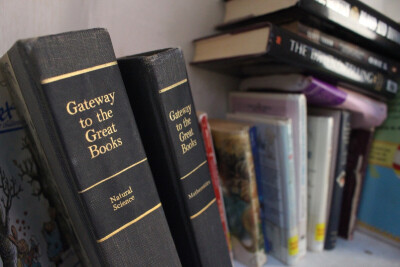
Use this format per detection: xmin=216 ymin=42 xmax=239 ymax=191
xmin=267 ymin=26 xmax=399 ymax=98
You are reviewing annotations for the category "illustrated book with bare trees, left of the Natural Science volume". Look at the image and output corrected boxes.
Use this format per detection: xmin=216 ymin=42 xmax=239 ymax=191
xmin=0 ymin=72 xmax=81 ymax=267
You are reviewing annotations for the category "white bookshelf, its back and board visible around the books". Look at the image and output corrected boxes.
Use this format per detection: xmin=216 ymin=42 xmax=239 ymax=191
xmin=0 ymin=0 xmax=400 ymax=267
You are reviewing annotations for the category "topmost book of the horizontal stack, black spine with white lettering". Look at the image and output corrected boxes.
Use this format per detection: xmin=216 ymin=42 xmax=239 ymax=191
xmin=217 ymin=0 xmax=400 ymax=59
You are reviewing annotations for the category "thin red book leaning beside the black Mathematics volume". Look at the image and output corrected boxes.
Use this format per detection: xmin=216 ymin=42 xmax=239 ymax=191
xmin=197 ymin=111 xmax=233 ymax=260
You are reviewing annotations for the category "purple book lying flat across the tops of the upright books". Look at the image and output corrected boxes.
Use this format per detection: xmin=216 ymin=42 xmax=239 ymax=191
xmin=239 ymin=73 xmax=387 ymax=129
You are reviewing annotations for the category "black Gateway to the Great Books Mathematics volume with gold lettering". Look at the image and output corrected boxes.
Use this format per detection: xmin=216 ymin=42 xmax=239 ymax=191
xmin=118 ymin=49 xmax=231 ymax=267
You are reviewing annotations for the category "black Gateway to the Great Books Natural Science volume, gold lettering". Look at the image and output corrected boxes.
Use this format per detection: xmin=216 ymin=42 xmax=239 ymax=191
xmin=2 ymin=29 xmax=180 ymax=266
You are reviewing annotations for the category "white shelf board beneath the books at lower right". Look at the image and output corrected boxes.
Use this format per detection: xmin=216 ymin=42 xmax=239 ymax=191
xmin=235 ymin=231 xmax=400 ymax=267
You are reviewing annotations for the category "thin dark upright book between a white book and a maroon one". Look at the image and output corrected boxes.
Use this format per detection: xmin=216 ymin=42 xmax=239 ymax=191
xmin=324 ymin=111 xmax=351 ymax=250
